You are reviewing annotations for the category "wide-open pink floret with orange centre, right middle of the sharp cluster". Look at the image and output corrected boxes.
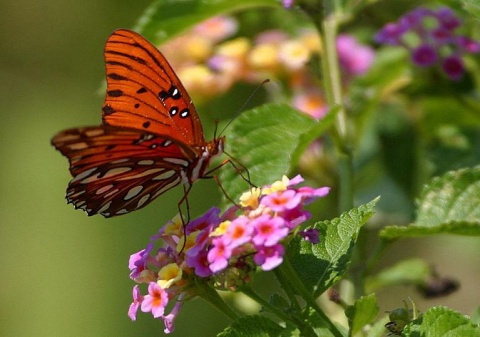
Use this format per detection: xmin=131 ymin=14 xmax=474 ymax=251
xmin=251 ymin=214 xmax=289 ymax=247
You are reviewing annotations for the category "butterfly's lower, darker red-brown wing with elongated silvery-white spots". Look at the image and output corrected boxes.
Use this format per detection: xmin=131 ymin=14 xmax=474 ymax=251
xmin=52 ymin=126 xmax=196 ymax=217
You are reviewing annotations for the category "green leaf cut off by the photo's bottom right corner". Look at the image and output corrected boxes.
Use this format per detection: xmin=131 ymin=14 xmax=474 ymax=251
xmin=403 ymin=307 xmax=480 ymax=337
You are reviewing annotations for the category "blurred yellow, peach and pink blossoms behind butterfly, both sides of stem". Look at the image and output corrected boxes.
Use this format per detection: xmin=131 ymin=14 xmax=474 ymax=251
xmin=161 ymin=16 xmax=374 ymax=119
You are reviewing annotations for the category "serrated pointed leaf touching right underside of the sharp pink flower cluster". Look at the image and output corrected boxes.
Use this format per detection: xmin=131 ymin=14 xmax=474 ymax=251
xmin=287 ymin=199 xmax=378 ymax=297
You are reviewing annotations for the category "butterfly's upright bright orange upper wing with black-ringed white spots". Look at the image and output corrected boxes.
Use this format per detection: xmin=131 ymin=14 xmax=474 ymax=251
xmin=103 ymin=29 xmax=205 ymax=145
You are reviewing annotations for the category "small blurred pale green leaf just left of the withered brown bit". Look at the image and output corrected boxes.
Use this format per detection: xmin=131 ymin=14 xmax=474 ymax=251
xmin=366 ymin=259 xmax=430 ymax=292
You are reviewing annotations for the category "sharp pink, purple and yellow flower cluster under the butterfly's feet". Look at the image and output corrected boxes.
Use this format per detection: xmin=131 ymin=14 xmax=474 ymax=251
xmin=128 ymin=175 xmax=329 ymax=333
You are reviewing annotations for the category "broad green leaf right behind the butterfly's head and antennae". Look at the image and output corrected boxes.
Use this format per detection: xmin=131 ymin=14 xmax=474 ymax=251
xmin=220 ymin=104 xmax=329 ymax=199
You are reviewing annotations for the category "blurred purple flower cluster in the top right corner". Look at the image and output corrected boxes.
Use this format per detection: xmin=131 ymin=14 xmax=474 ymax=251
xmin=375 ymin=7 xmax=480 ymax=80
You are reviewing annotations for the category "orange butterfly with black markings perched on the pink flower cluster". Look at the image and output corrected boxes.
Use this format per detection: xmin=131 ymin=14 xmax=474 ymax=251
xmin=52 ymin=29 xmax=225 ymax=217
